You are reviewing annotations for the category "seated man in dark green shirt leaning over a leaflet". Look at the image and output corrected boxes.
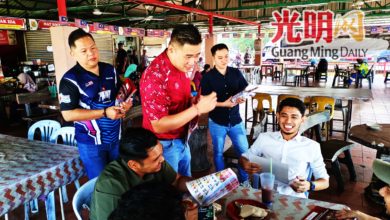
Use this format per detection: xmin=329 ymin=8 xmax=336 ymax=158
xmin=90 ymin=128 xmax=190 ymax=220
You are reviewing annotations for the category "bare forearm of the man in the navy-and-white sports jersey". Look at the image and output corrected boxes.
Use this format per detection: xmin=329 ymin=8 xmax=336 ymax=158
xmin=61 ymin=108 xmax=104 ymax=121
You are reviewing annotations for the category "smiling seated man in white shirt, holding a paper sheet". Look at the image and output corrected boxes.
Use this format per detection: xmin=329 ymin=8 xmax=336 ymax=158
xmin=240 ymin=98 xmax=329 ymax=198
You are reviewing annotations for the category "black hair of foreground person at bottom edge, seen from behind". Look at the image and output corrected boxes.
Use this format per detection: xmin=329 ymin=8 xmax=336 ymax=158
xmin=109 ymin=182 xmax=185 ymax=220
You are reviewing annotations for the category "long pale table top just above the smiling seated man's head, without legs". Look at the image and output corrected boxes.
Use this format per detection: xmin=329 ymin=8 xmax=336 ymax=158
xmin=255 ymin=85 xmax=372 ymax=100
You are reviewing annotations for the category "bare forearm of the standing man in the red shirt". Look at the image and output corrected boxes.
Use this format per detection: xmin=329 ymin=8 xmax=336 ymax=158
xmin=151 ymin=105 xmax=198 ymax=134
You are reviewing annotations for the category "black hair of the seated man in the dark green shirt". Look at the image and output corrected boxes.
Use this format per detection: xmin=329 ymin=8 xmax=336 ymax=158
xmin=119 ymin=128 xmax=158 ymax=162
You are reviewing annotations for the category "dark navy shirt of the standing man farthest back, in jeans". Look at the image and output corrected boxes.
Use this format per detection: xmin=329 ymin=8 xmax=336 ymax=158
xmin=201 ymin=67 xmax=248 ymax=126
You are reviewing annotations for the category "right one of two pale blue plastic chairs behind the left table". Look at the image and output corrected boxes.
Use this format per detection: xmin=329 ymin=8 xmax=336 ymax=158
xmin=50 ymin=127 xmax=80 ymax=219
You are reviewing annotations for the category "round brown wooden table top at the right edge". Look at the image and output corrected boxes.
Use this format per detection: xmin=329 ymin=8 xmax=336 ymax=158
xmin=349 ymin=124 xmax=390 ymax=149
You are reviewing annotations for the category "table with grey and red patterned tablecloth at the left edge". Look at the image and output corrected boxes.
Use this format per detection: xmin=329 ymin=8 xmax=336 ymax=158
xmin=0 ymin=134 xmax=85 ymax=219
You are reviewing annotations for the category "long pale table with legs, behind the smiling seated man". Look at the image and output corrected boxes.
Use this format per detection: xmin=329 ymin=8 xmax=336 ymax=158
xmin=245 ymin=85 xmax=373 ymax=139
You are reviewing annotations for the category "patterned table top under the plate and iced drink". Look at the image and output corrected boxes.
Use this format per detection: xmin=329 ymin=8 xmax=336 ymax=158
xmin=223 ymin=186 xmax=346 ymax=220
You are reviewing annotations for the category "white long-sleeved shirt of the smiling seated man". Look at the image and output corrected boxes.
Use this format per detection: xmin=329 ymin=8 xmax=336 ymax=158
xmin=242 ymin=132 xmax=329 ymax=198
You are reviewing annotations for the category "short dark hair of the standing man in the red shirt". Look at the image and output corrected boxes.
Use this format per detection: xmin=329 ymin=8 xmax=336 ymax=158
xmin=170 ymin=24 xmax=202 ymax=46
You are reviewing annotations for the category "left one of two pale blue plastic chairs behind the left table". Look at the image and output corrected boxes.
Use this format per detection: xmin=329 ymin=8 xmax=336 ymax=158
xmin=24 ymin=120 xmax=61 ymax=219
